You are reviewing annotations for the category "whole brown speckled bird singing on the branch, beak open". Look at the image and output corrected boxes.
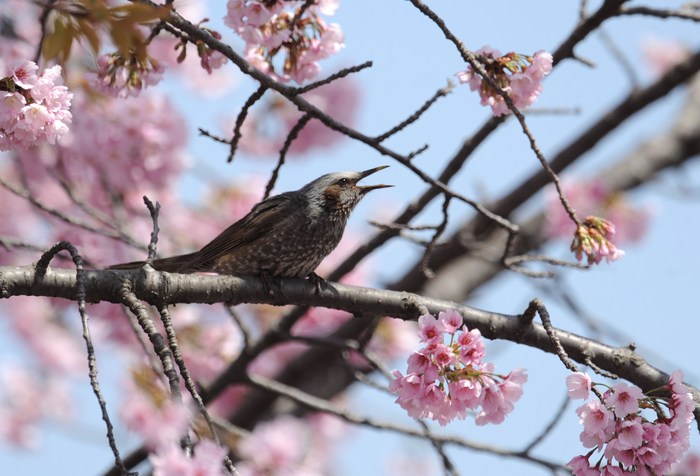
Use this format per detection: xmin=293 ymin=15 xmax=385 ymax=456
xmin=110 ymin=165 xmax=391 ymax=279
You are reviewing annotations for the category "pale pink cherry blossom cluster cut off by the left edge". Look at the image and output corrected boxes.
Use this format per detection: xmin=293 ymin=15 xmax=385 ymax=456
xmin=0 ymin=61 xmax=73 ymax=150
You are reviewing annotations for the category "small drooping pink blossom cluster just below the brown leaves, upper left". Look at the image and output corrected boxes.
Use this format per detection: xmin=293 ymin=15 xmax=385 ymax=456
xmin=89 ymin=51 xmax=164 ymax=97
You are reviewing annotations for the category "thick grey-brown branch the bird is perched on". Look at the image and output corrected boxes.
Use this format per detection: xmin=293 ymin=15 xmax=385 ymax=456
xmin=0 ymin=266 xmax=700 ymax=416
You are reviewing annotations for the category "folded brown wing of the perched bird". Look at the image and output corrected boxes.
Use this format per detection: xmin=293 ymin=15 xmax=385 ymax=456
xmin=184 ymin=192 xmax=300 ymax=271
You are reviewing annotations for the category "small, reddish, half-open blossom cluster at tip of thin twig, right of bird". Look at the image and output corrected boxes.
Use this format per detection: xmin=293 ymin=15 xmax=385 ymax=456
xmin=571 ymin=215 xmax=625 ymax=264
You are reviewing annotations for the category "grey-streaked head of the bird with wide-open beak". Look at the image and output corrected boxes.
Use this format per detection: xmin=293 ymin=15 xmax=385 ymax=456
xmin=300 ymin=165 xmax=392 ymax=217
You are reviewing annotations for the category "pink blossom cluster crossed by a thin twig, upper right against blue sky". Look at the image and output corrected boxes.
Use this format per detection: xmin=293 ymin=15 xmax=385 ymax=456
xmin=457 ymin=46 xmax=552 ymax=116
